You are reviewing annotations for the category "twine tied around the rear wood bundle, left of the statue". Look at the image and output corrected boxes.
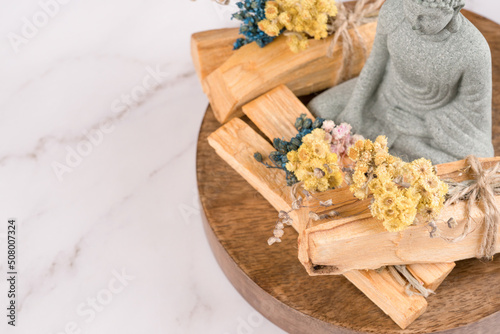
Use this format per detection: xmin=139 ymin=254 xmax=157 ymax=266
xmin=327 ymin=0 xmax=385 ymax=83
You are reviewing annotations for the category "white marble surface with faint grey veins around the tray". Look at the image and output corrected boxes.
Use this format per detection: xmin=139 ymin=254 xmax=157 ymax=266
xmin=0 ymin=0 xmax=500 ymax=334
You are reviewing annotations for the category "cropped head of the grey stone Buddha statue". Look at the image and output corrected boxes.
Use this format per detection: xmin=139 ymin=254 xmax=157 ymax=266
xmin=403 ymin=0 xmax=465 ymax=35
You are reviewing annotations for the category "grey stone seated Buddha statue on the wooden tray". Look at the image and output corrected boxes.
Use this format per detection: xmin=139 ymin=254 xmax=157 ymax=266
xmin=308 ymin=0 xmax=494 ymax=164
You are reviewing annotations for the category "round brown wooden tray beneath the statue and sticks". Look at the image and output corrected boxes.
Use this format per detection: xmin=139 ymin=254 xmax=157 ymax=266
xmin=196 ymin=11 xmax=500 ymax=334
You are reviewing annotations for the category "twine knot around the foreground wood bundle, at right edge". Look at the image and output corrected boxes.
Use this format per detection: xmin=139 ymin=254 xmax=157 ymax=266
xmin=443 ymin=155 xmax=500 ymax=260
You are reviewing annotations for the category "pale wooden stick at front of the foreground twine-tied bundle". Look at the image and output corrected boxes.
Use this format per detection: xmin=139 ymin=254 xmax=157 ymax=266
xmin=301 ymin=158 xmax=500 ymax=279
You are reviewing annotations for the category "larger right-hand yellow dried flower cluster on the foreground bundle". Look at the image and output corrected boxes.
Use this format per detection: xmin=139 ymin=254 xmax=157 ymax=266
xmin=349 ymin=136 xmax=448 ymax=232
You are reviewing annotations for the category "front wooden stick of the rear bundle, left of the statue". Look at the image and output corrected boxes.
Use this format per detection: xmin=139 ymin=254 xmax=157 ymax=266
xmin=204 ymin=22 xmax=377 ymax=123
